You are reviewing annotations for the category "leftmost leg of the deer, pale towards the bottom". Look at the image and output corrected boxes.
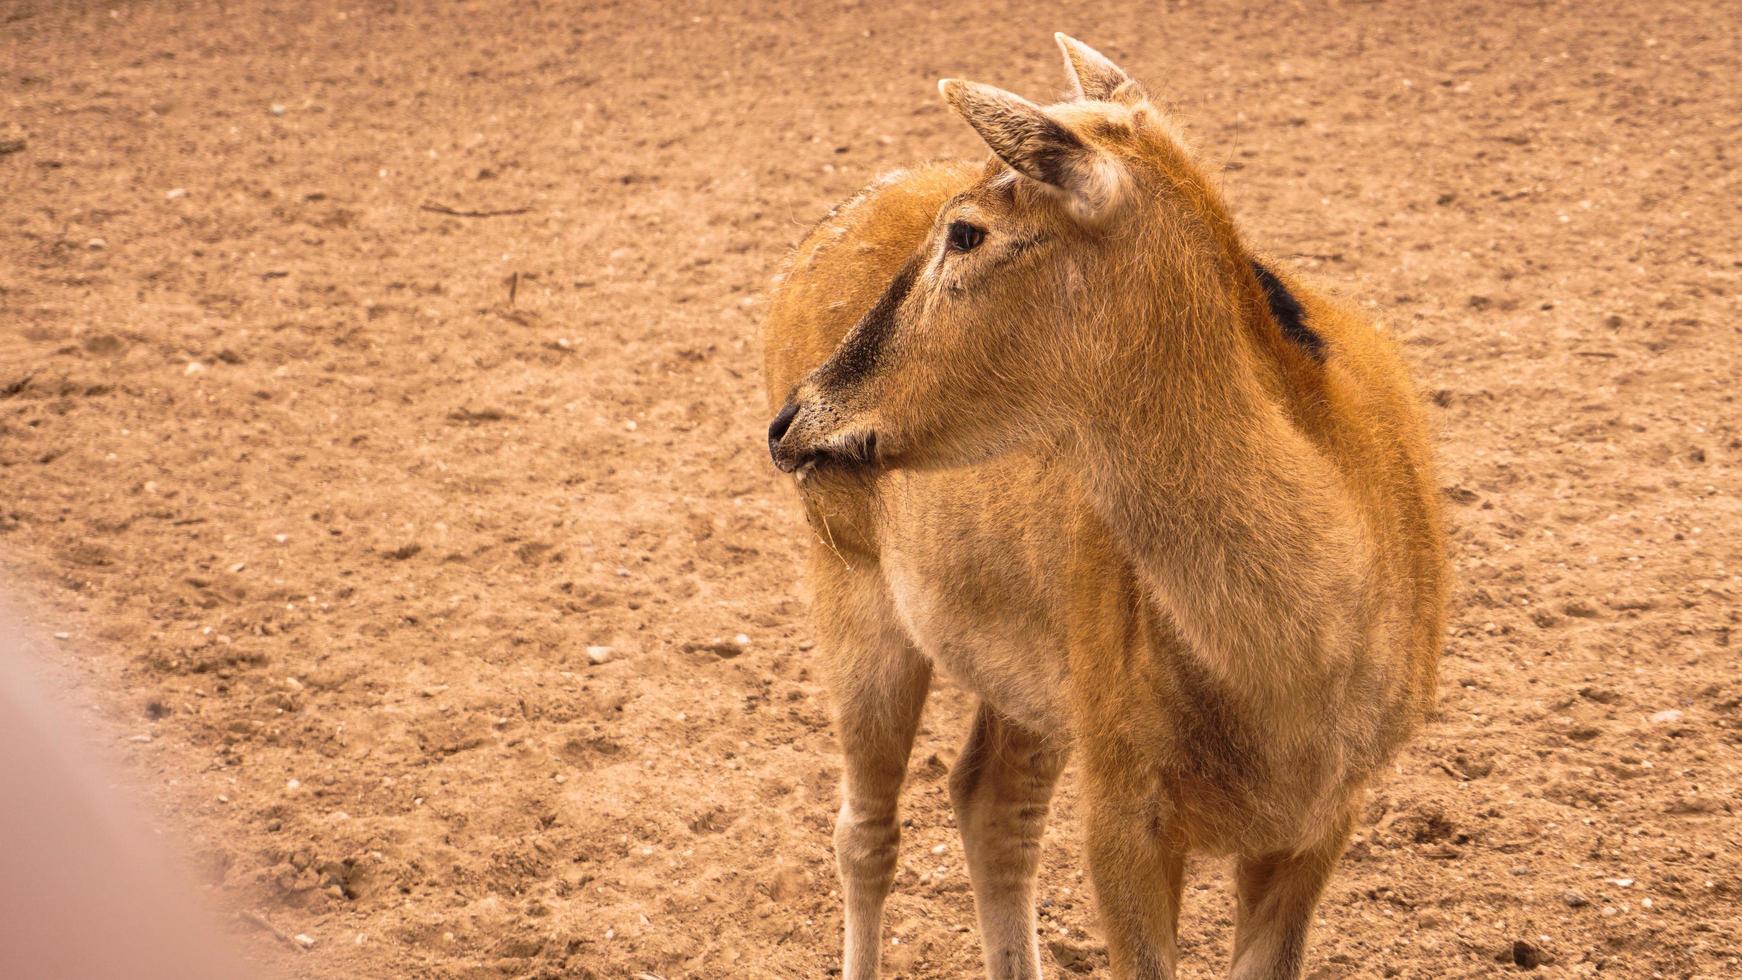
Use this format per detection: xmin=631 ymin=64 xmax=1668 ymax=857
xmin=831 ymin=605 xmax=932 ymax=980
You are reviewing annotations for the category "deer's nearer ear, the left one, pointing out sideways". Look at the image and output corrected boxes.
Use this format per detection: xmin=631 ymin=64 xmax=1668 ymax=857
xmin=937 ymin=78 xmax=1118 ymax=216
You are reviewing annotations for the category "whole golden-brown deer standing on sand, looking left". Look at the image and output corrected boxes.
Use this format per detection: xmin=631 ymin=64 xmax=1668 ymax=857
xmin=763 ymin=35 xmax=1449 ymax=980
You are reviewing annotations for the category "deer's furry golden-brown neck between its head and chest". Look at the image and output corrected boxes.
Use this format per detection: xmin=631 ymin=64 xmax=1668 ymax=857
xmin=1078 ymin=294 xmax=1367 ymax=684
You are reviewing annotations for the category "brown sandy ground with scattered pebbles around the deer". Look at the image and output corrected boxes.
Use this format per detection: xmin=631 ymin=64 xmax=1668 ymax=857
xmin=0 ymin=0 xmax=1742 ymax=978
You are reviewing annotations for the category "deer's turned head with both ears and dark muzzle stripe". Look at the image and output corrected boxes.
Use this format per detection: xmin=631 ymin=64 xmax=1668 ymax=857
xmin=768 ymin=35 xmax=1249 ymax=475
